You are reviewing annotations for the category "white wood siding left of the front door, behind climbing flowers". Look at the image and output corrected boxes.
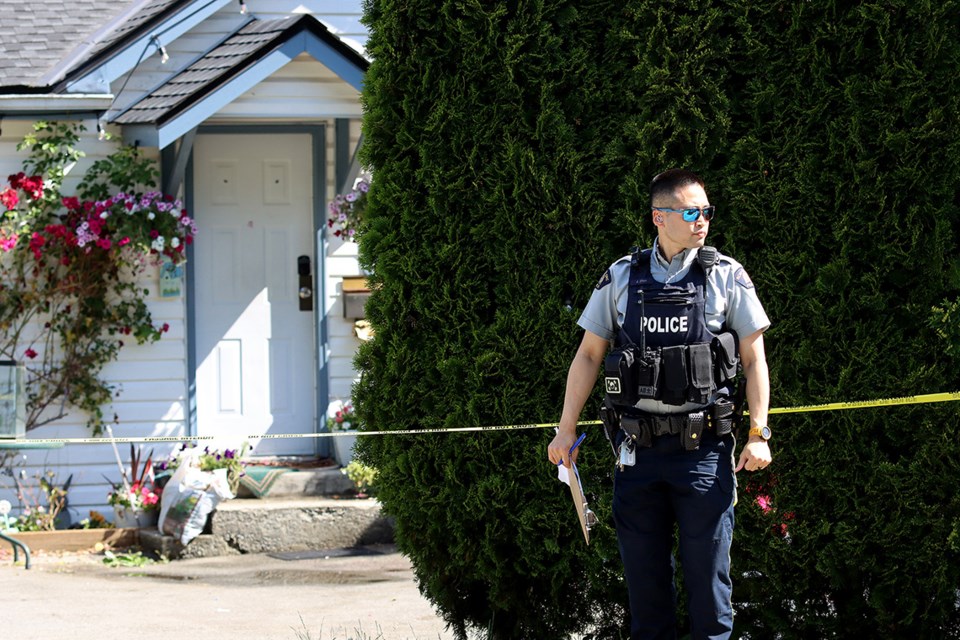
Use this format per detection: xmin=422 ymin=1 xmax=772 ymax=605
xmin=0 ymin=119 xmax=189 ymax=522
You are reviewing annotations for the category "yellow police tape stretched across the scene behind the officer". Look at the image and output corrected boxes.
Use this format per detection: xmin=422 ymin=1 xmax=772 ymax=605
xmin=7 ymin=391 xmax=960 ymax=449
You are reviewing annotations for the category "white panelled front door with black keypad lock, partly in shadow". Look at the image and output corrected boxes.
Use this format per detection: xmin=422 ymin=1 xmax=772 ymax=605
xmin=193 ymin=133 xmax=317 ymax=455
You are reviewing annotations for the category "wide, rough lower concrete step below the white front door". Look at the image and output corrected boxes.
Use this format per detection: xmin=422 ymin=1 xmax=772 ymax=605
xmin=140 ymin=498 xmax=393 ymax=559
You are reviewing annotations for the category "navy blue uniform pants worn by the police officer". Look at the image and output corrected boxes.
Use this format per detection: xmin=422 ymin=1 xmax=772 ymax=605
xmin=613 ymin=432 xmax=735 ymax=640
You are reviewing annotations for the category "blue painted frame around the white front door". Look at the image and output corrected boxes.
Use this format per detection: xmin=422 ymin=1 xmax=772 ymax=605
xmin=184 ymin=124 xmax=332 ymax=457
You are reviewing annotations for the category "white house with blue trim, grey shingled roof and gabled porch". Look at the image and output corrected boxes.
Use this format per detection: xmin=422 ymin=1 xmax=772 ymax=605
xmin=0 ymin=0 xmax=367 ymax=518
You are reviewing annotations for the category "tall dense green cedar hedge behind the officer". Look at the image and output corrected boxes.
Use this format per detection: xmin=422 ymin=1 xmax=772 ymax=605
xmin=355 ymin=0 xmax=960 ymax=638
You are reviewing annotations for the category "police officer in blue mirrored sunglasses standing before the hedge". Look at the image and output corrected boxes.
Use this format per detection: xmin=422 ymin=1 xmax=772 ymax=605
xmin=548 ymin=169 xmax=771 ymax=640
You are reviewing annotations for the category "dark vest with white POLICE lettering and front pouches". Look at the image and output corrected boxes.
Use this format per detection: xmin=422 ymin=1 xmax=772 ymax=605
xmin=604 ymin=248 xmax=739 ymax=410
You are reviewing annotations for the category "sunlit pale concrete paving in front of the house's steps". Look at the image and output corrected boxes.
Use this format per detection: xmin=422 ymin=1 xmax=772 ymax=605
xmin=0 ymin=545 xmax=453 ymax=640
